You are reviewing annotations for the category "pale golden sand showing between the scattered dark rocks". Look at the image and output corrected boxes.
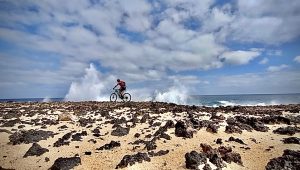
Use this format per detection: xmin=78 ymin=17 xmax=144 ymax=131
xmin=0 ymin=101 xmax=300 ymax=170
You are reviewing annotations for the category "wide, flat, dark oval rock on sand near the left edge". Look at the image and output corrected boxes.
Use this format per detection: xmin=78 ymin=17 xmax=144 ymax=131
xmin=9 ymin=129 xmax=56 ymax=145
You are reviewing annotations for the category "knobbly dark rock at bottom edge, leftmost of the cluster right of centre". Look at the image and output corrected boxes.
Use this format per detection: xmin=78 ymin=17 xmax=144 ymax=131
xmin=185 ymin=151 xmax=207 ymax=169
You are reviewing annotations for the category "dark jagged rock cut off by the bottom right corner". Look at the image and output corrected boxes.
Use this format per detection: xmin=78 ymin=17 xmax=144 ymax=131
xmin=266 ymin=149 xmax=300 ymax=170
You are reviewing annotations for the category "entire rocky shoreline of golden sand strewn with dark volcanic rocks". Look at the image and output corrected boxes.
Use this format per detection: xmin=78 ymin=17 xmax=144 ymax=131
xmin=0 ymin=101 xmax=300 ymax=169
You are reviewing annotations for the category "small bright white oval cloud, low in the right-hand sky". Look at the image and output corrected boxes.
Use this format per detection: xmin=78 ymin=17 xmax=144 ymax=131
xmin=220 ymin=50 xmax=261 ymax=65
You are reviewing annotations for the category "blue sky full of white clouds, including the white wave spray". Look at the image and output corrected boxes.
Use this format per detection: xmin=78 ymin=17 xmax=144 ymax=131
xmin=0 ymin=0 xmax=300 ymax=100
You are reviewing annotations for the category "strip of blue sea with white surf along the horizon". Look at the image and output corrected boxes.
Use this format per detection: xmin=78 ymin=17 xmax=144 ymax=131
xmin=0 ymin=93 xmax=300 ymax=107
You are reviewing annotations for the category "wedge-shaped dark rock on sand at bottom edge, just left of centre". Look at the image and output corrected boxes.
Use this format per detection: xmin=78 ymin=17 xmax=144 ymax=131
xmin=116 ymin=152 xmax=151 ymax=169
